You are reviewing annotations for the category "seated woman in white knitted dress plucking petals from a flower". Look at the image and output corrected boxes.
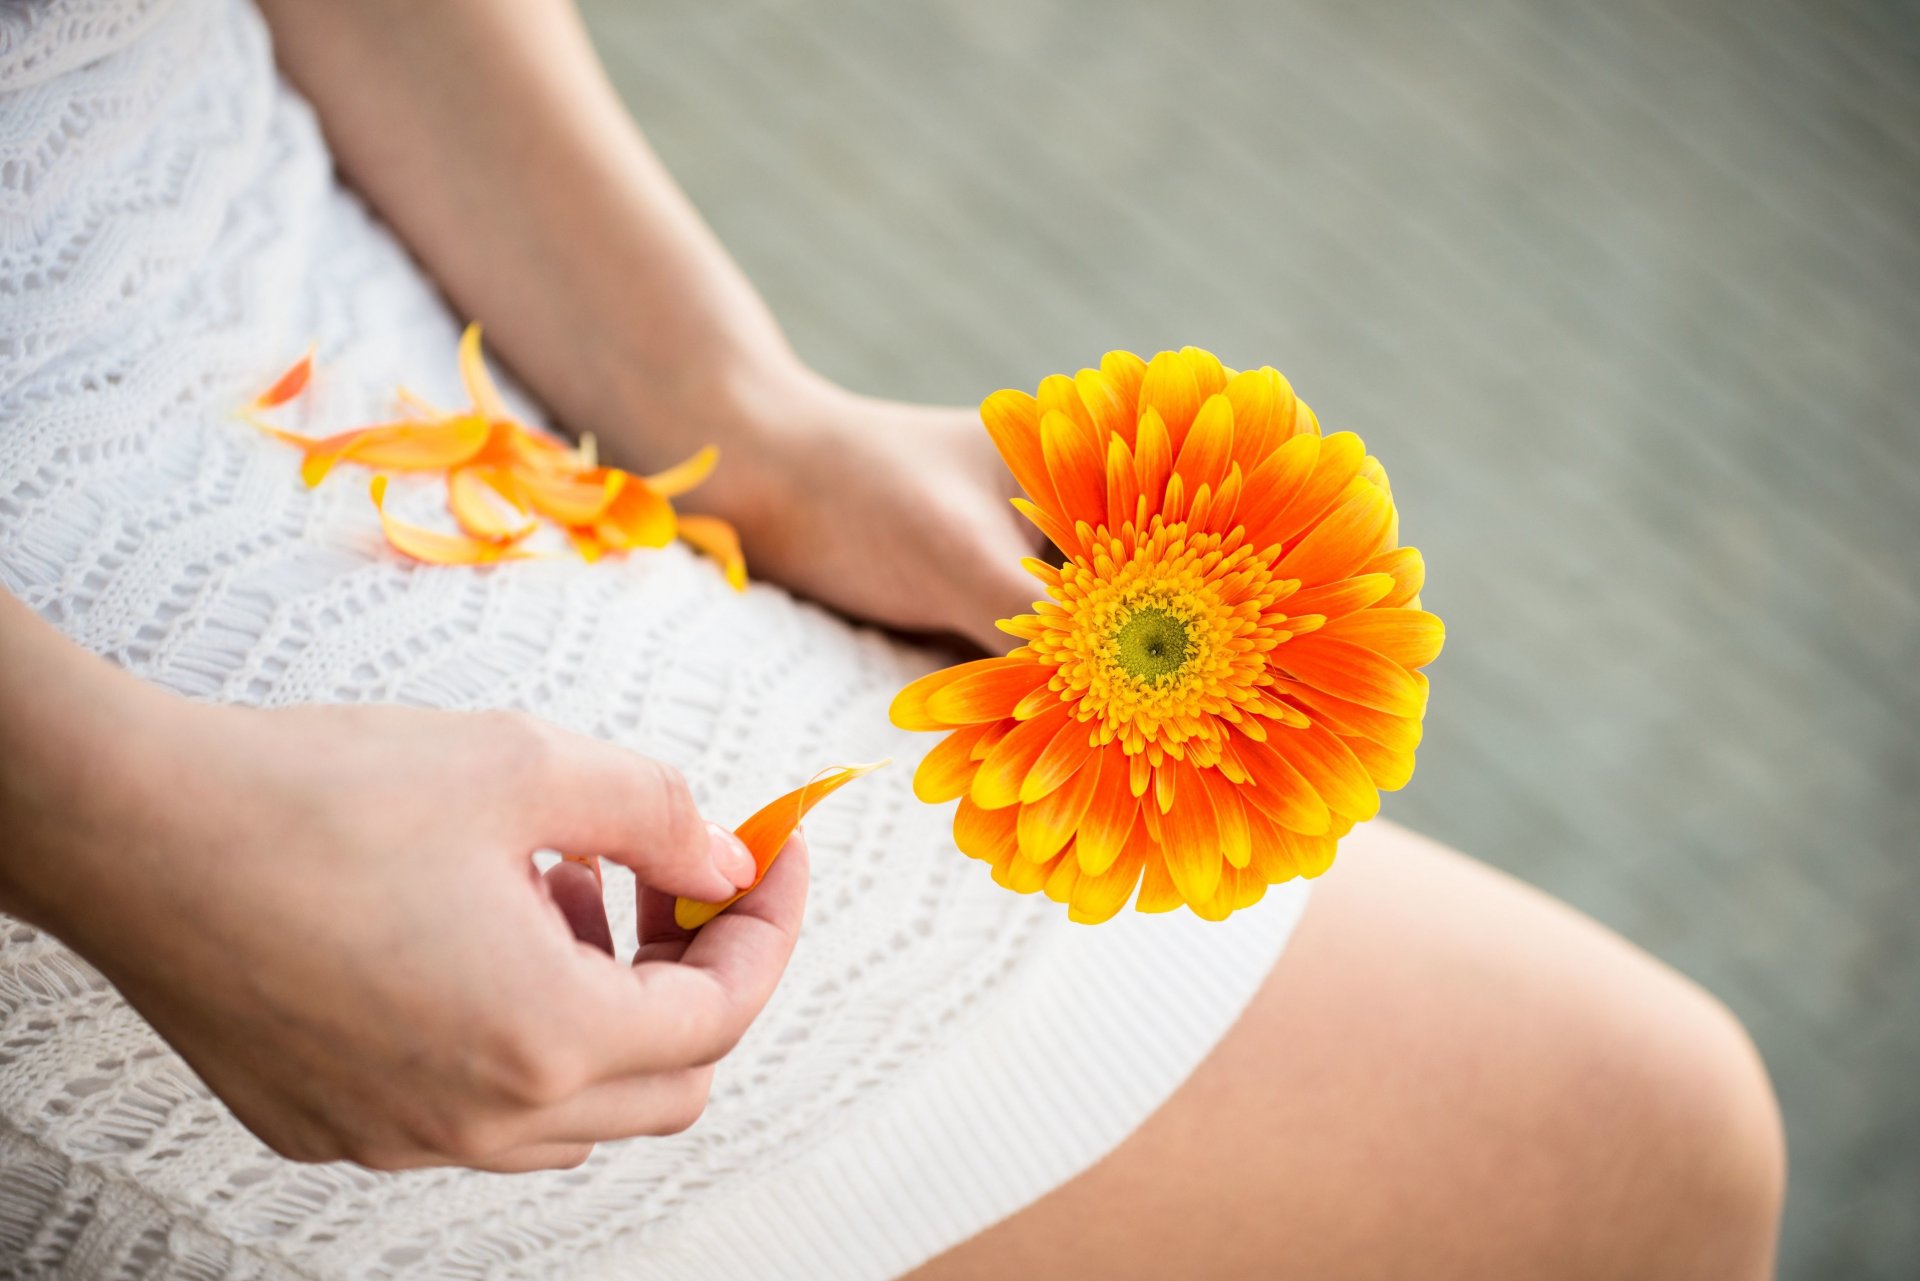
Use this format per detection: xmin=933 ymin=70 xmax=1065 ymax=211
xmin=0 ymin=0 xmax=1784 ymax=1277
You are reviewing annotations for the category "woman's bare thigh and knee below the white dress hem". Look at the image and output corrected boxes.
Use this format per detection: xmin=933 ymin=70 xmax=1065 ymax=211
xmin=916 ymin=824 xmax=1784 ymax=1281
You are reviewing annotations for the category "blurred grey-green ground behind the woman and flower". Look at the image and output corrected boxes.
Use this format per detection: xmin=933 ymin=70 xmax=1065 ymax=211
xmin=586 ymin=0 xmax=1920 ymax=1281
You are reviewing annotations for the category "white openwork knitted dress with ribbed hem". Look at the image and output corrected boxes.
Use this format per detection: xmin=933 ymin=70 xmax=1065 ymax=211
xmin=0 ymin=0 xmax=1306 ymax=1281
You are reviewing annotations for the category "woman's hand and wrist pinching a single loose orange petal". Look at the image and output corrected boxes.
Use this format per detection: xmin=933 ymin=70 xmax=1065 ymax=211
xmin=0 ymin=618 xmax=806 ymax=1170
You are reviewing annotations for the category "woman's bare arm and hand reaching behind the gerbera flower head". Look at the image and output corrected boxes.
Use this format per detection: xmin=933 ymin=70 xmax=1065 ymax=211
xmin=263 ymin=0 xmax=1035 ymax=647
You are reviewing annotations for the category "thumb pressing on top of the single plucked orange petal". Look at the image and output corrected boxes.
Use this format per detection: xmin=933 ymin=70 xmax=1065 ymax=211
xmin=536 ymin=730 xmax=756 ymax=903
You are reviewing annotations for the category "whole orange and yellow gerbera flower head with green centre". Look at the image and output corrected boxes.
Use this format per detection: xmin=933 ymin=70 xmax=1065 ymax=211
xmin=893 ymin=348 xmax=1444 ymax=922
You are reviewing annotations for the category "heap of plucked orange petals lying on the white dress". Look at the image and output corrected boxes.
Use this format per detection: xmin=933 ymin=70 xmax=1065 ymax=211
xmin=242 ymin=325 xmax=747 ymax=592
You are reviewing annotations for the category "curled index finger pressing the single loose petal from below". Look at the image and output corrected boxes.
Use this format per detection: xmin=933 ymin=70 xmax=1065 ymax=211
xmin=586 ymin=837 xmax=806 ymax=1079
